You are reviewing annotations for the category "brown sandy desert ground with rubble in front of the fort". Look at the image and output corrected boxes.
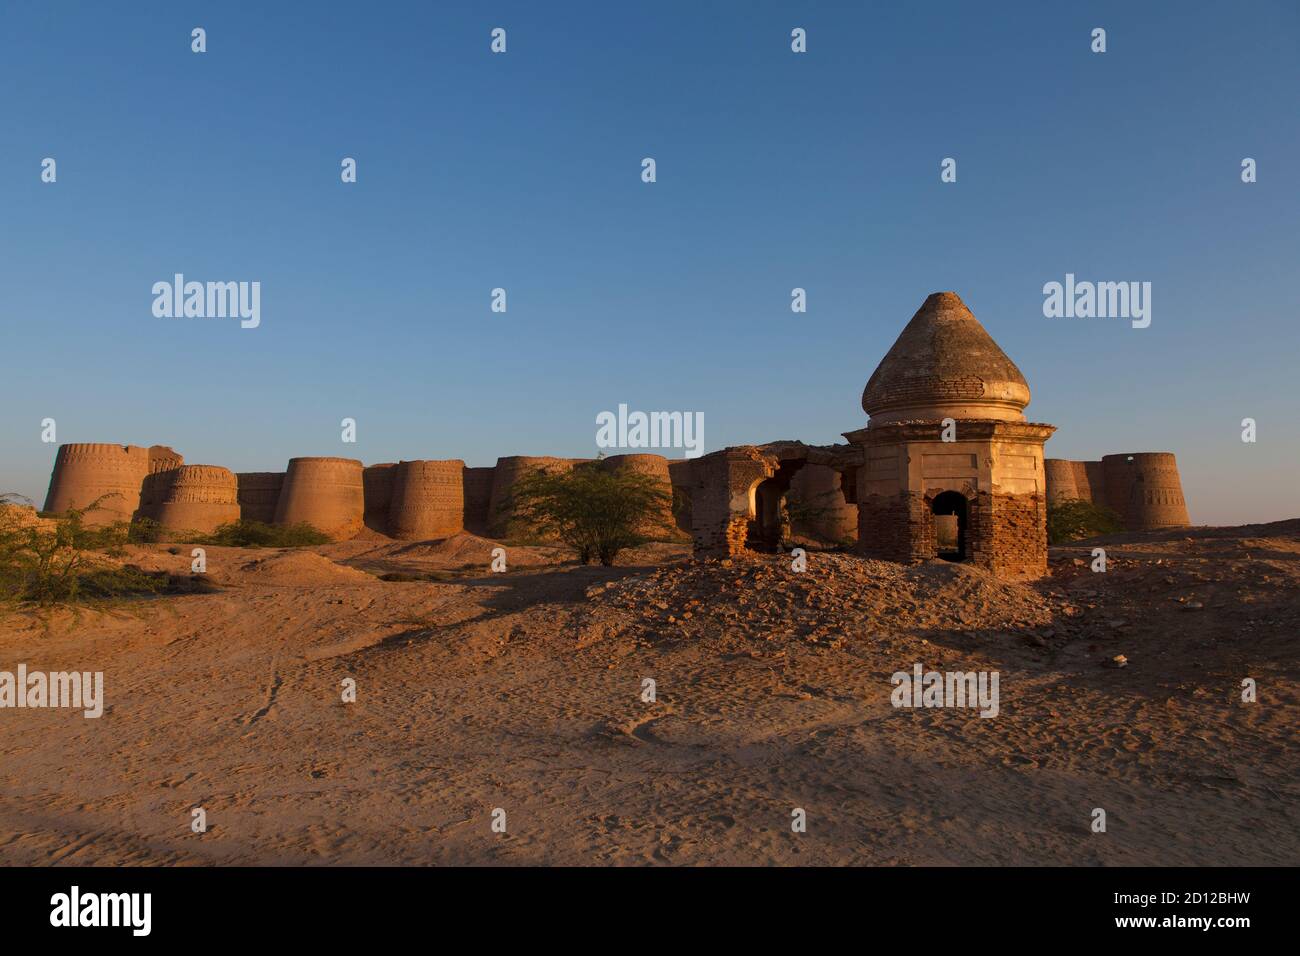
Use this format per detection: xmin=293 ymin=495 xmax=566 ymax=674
xmin=0 ymin=520 xmax=1300 ymax=865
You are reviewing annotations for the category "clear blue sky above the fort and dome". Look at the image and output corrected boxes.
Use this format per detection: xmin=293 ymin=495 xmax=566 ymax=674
xmin=0 ymin=0 xmax=1300 ymax=523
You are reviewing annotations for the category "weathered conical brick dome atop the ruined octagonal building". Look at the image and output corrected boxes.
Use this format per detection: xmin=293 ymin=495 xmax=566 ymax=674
xmin=862 ymin=293 xmax=1030 ymax=424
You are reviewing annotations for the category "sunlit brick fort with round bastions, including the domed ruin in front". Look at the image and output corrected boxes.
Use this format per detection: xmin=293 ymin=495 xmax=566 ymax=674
xmin=32 ymin=293 xmax=1190 ymax=579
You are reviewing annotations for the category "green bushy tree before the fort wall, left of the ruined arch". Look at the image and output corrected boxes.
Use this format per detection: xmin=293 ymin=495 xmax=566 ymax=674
xmin=511 ymin=464 xmax=672 ymax=566
